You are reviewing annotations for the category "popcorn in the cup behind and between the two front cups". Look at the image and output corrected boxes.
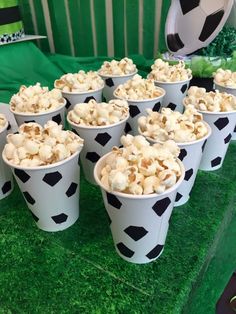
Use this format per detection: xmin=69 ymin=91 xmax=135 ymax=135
xmin=68 ymin=99 xmax=129 ymax=126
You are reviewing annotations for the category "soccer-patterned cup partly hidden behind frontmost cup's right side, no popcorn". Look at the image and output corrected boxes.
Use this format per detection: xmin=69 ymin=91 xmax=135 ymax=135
xmin=144 ymin=122 xmax=211 ymax=206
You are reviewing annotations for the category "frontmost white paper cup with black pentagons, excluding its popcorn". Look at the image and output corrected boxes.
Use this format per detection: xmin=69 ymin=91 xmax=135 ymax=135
xmin=94 ymin=153 xmax=184 ymax=264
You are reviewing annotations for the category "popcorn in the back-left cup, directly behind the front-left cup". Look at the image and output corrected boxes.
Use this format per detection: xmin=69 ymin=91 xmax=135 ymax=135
xmin=10 ymin=83 xmax=65 ymax=114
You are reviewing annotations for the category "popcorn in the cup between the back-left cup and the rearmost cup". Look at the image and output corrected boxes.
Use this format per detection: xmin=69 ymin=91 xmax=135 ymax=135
xmin=54 ymin=70 xmax=104 ymax=93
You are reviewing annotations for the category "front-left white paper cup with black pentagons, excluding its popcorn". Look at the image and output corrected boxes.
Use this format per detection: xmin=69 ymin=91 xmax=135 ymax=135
xmin=3 ymin=152 xmax=80 ymax=232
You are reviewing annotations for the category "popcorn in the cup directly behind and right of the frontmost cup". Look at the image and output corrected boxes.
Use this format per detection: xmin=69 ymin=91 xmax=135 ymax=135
xmin=138 ymin=105 xmax=208 ymax=143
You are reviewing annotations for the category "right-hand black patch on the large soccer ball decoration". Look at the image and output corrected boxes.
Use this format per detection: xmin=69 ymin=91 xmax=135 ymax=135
xmin=199 ymin=10 xmax=225 ymax=42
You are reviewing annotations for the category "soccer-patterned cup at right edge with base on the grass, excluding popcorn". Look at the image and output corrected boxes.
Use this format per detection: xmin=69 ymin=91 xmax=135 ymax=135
xmin=199 ymin=111 xmax=236 ymax=171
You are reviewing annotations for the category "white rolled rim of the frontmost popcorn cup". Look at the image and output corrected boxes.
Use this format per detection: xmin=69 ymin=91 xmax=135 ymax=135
xmin=93 ymin=152 xmax=185 ymax=199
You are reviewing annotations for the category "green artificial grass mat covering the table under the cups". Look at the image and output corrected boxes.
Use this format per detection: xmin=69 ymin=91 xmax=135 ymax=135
xmin=0 ymin=144 xmax=236 ymax=314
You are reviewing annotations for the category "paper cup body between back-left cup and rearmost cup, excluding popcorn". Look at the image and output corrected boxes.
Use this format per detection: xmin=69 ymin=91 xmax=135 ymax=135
xmin=62 ymin=86 xmax=104 ymax=111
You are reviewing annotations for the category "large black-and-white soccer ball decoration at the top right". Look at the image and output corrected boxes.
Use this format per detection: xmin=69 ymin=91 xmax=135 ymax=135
xmin=165 ymin=0 xmax=234 ymax=55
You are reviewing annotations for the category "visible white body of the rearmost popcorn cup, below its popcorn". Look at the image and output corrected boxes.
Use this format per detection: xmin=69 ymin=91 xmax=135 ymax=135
xmin=98 ymin=71 xmax=138 ymax=102
